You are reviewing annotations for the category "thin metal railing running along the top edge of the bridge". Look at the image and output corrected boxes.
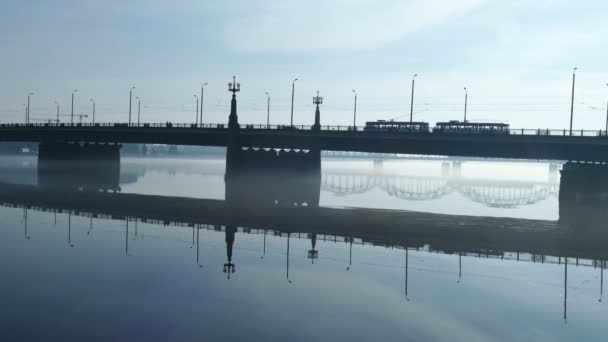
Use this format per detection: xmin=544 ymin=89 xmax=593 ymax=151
xmin=0 ymin=122 xmax=608 ymax=137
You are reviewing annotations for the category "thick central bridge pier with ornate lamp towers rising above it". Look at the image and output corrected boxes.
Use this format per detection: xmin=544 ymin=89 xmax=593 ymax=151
xmin=224 ymin=79 xmax=321 ymax=207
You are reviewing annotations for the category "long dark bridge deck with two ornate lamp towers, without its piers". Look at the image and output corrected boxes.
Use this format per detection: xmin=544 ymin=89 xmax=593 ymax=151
xmin=0 ymin=83 xmax=608 ymax=162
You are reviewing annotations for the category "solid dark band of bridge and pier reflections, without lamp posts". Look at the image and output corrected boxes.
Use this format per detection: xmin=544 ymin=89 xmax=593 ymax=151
xmin=0 ymin=156 xmax=608 ymax=260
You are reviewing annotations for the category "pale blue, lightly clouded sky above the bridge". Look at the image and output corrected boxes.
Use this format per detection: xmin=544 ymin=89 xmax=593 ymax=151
xmin=0 ymin=0 xmax=608 ymax=129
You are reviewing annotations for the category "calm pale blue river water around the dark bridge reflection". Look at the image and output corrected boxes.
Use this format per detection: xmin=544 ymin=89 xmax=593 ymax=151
xmin=0 ymin=157 xmax=608 ymax=341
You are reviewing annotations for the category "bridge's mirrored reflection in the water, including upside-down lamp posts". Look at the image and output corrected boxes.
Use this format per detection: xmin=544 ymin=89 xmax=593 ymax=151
xmin=0 ymin=158 xmax=608 ymax=318
